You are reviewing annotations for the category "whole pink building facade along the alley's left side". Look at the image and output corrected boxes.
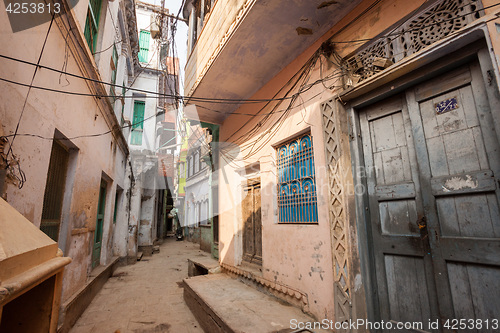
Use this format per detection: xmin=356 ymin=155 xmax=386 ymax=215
xmin=0 ymin=1 xmax=152 ymax=331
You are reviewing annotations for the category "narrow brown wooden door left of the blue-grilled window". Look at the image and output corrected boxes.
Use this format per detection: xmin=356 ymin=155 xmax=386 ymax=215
xmin=242 ymin=179 xmax=262 ymax=265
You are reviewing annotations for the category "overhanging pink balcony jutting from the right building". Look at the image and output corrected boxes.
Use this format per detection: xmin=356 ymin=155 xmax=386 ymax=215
xmin=184 ymin=0 xmax=361 ymax=124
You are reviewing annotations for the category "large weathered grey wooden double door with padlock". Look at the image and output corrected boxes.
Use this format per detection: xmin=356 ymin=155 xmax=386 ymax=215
xmin=359 ymin=63 xmax=500 ymax=332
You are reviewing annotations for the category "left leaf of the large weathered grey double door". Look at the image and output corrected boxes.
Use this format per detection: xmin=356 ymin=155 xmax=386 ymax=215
xmin=360 ymin=96 xmax=436 ymax=330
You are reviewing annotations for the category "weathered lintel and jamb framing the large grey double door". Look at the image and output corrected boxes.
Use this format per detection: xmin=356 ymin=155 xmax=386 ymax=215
xmin=344 ymin=26 xmax=500 ymax=321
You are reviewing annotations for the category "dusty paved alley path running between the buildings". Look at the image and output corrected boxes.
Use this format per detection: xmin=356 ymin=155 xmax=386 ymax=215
xmin=70 ymin=238 xmax=204 ymax=333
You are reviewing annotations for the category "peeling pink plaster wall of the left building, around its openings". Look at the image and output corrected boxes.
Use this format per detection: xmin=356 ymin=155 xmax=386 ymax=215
xmin=0 ymin=1 xmax=128 ymax=302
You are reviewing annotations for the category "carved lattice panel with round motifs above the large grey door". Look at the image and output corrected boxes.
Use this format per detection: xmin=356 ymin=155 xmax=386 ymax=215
xmin=347 ymin=0 xmax=483 ymax=83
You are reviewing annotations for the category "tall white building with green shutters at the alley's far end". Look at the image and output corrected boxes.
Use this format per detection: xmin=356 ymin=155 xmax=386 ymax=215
xmin=126 ymin=2 xmax=179 ymax=255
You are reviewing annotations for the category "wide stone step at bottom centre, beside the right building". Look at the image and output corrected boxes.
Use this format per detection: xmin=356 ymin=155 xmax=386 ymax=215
xmin=184 ymin=273 xmax=327 ymax=333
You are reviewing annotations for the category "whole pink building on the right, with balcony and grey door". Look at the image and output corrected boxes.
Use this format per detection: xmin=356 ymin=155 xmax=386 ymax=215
xmin=184 ymin=0 xmax=500 ymax=330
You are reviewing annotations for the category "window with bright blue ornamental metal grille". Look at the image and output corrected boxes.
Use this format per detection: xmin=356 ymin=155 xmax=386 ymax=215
xmin=277 ymin=134 xmax=318 ymax=223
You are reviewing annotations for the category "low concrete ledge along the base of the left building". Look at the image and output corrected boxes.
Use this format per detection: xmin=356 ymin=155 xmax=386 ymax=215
xmin=57 ymin=257 xmax=123 ymax=333
